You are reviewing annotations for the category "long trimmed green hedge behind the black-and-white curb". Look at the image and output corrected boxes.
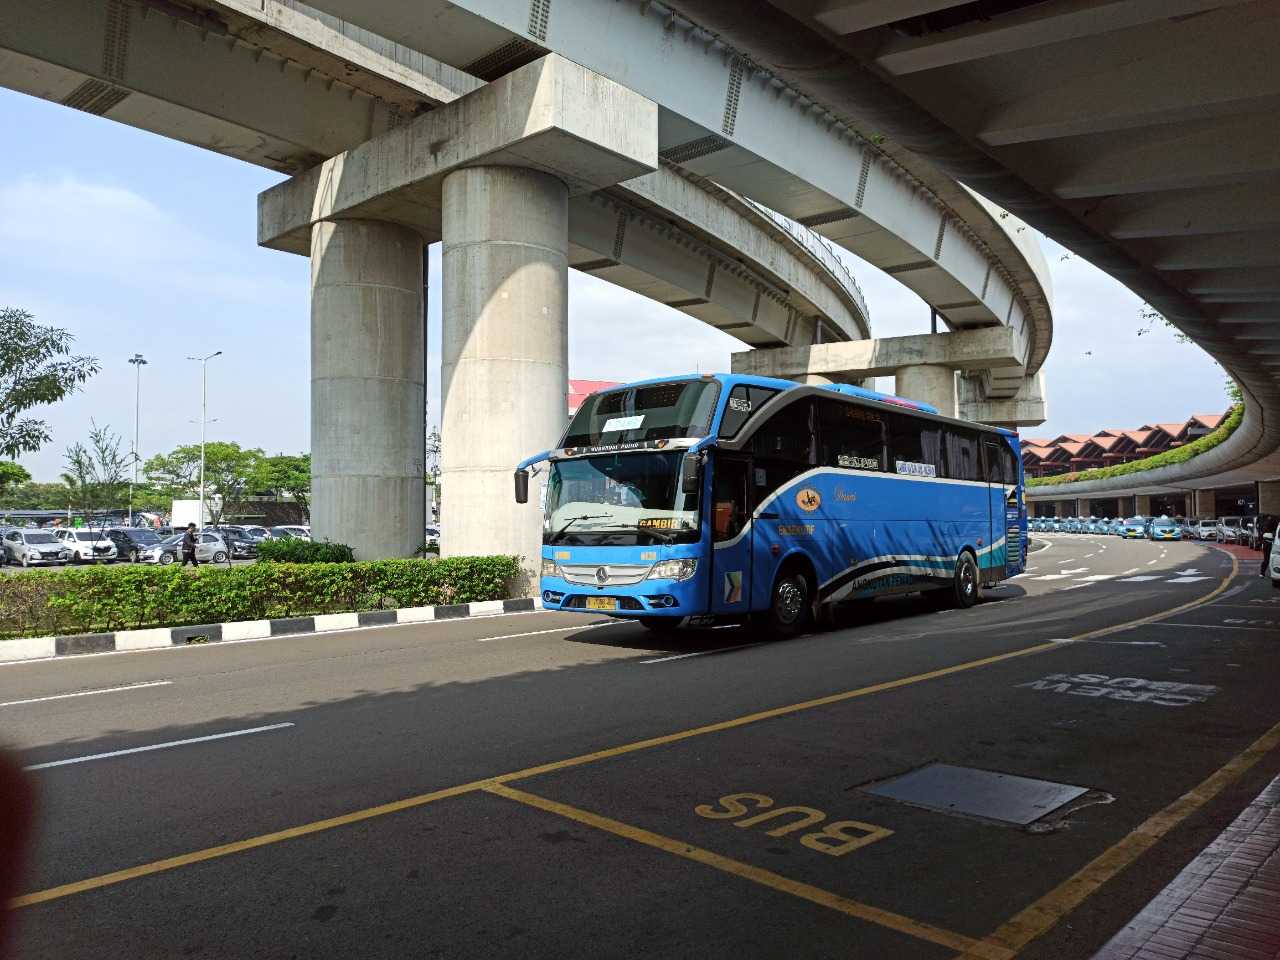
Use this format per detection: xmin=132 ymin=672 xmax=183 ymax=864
xmin=0 ymin=557 xmax=522 ymax=639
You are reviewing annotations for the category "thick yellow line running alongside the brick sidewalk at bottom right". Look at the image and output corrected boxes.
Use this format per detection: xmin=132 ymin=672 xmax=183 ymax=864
xmin=956 ymin=723 xmax=1280 ymax=960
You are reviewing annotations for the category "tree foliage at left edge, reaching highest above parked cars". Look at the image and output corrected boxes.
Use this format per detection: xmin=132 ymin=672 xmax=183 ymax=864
xmin=0 ymin=307 xmax=99 ymax=458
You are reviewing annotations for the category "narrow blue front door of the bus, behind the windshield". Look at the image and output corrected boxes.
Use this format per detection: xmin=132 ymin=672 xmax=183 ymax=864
xmin=709 ymin=451 xmax=753 ymax=613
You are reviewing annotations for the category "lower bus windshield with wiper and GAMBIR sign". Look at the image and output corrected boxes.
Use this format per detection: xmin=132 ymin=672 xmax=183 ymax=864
xmin=543 ymin=452 xmax=699 ymax=545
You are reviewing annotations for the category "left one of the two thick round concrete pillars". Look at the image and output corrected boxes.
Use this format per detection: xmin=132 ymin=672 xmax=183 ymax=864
xmin=311 ymin=220 xmax=426 ymax=559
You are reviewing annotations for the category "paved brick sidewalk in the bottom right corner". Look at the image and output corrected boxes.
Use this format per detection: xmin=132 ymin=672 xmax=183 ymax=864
xmin=1093 ymin=783 xmax=1280 ymax=960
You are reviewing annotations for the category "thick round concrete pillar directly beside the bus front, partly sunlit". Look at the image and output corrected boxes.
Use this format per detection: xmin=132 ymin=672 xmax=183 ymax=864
xmin=440 ymin=166 xmax=568 ymax=572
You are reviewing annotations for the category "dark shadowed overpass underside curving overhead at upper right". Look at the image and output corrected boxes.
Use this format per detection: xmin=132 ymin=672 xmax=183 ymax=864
xmin=660 ymin=0 xmax=1280 ymax=513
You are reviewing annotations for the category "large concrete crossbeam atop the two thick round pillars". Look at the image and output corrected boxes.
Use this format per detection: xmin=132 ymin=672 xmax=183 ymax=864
xmin=259 ymin=55 xmax=658 ymax=253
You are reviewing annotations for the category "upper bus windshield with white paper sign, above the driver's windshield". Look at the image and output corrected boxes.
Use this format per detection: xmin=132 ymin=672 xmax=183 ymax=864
xmin=563 ymin=380 xmax=719 ymax=447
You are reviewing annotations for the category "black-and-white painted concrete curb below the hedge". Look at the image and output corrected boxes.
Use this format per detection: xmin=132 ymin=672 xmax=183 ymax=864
xmin=0 ymin=596 xmax=541 ymax=663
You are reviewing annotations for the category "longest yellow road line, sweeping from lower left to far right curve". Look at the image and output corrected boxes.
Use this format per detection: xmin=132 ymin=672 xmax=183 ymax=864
xmin=9 ymin=568 xmax=1239 ymax=909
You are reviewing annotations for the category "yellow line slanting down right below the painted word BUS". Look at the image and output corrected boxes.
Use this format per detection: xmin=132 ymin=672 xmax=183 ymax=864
xmin=483 ymin=783 xmax=1010 ymax=960
